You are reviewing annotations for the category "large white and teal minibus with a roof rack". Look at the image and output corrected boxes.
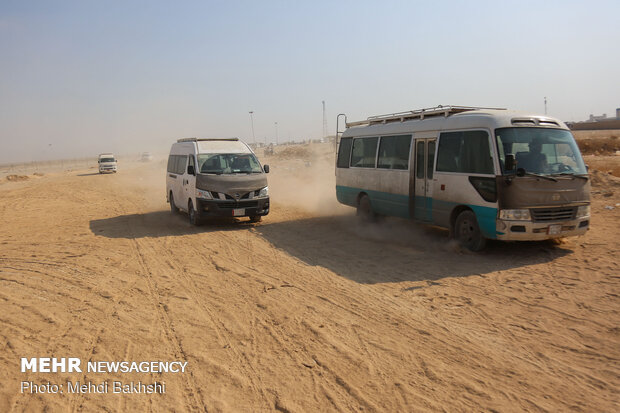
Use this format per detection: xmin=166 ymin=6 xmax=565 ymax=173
xmin=336 ymin=106 xmax=590 ymax=250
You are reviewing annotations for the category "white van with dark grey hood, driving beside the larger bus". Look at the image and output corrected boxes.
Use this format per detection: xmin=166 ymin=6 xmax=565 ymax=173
xmin=166 ymin=138 xmax=269 ymax=225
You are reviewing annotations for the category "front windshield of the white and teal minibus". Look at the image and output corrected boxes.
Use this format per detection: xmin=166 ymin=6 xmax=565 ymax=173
xmin=495 ymin=128 xmax=587 ymax=175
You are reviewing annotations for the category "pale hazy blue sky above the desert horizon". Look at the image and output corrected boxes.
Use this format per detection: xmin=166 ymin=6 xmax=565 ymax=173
xmin=0 ymin=0 xmax=620 ymax=163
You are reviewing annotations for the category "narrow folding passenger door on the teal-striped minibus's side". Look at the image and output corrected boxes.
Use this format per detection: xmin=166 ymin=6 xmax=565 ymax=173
xmin=413 ymin=138 xmax=437 ymax=222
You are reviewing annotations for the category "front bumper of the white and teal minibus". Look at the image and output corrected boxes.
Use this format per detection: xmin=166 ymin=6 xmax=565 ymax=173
xmin=496 ymin=217 xmax=590 ymax=241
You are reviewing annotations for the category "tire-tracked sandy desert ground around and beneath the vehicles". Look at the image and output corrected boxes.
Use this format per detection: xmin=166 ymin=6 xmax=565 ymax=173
xmin=0 ymin=146 xmax=620 ymax=412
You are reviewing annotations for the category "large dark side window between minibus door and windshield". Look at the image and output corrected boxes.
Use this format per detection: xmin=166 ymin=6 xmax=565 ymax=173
xmin=437 ymin=131 xmax=494 ymax=174
